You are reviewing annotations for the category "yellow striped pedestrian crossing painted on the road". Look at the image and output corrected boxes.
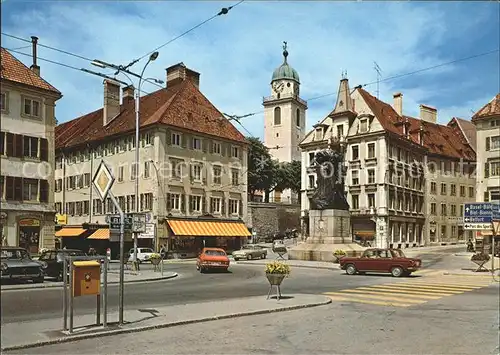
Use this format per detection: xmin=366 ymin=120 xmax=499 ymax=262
xmin=324 ymin=275 xmax=491 ymax=307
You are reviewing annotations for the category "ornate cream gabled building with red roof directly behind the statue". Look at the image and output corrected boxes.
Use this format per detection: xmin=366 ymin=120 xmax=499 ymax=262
xmin=300 ymin=78 xmax=475 ymax=247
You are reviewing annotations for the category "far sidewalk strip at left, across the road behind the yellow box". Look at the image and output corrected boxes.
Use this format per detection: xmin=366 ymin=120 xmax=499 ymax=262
xmin=1 ymin=270 xmax=178 ymax=292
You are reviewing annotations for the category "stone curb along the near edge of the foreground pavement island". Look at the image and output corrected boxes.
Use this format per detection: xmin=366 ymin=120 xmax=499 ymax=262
xmin=0 ymin=296 xmax=332 ymax=352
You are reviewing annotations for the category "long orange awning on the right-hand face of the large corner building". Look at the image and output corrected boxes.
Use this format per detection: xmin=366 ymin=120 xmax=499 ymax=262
xmin=167 ymin=220 xmax=251 ymax=237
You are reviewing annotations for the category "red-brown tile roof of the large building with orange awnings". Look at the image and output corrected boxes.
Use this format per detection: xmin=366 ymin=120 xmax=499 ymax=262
xmin=55 ymin=80 xmax=246 ymax=149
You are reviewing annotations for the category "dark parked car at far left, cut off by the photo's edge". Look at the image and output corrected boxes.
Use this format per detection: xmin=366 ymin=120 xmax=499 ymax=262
xmin=0 ymin=247 xmax=45 ymax=283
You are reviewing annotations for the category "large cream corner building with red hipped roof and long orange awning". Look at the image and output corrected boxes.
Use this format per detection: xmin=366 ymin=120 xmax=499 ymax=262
xmin=56 ymin=63 xmax=249 ymax=255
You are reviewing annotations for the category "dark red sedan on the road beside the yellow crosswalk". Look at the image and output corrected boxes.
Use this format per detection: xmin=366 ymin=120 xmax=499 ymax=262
xmin=339 ymin=248 xmax=422 ymax=277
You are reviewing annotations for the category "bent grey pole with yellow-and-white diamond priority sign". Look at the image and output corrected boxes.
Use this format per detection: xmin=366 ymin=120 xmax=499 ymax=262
xmin=92 ymin=160 xmax=125 ymax=325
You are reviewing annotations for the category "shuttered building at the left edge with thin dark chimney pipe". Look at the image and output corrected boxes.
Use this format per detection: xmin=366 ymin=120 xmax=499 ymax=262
xmin=0 ymin=42 xmax=62 ymax=253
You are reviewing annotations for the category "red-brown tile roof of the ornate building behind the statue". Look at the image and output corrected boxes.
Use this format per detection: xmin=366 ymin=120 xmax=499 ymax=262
xmin=358 ymin=88 xmax=476 ymax=161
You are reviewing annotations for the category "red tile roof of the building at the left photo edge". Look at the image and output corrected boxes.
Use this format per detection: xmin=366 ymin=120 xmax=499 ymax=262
xmin=0 ymin=47 xmax=61 ymax=95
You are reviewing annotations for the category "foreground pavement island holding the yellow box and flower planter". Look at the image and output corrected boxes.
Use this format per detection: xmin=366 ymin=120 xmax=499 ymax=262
xmin=1 ymin=294 xmax=332 ymax=351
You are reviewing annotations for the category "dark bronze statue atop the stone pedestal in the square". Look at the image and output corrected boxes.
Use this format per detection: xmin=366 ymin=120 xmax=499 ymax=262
xmin=311 ymin=149 xmax=349 ymax=211
